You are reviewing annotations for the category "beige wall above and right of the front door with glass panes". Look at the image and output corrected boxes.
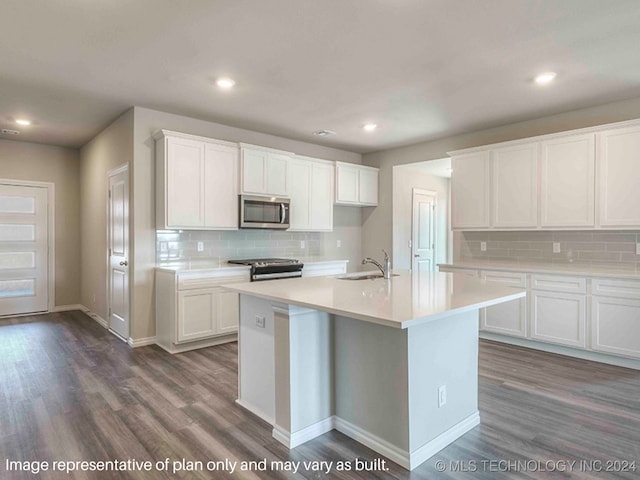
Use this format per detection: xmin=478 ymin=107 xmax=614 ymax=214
xmin=0 ymin=140 xmax=80 ymax=306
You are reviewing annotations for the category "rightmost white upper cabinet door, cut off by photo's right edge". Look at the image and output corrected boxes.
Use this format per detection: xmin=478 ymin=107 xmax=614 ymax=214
xmin=599 ymin=127 xmax=640 ymax=227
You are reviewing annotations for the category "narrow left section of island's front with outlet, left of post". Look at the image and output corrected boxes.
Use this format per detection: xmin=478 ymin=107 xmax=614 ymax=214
xmin=238 ymin=295 xmax=275 ymax=425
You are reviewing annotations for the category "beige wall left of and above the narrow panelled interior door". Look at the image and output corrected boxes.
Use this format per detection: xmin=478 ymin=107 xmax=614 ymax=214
xmin=79 ymin=109 xmax=134 ymax=320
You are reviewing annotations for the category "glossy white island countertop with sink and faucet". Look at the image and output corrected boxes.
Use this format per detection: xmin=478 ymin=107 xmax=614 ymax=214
xmin=224 ymin=270 xmax=526 ymax=328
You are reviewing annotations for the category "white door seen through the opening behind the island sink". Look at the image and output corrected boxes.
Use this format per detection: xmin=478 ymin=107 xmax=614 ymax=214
xmin=411 ymin=189 xmax=436 ymax=272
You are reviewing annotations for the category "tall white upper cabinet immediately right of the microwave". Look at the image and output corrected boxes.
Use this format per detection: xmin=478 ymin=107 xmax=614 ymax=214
xmin=287 ymin=156 xmax=334 ymax=231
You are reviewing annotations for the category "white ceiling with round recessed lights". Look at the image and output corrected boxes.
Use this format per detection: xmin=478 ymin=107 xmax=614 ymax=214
xmin=0 ymin=0 xmax=640 ymax=153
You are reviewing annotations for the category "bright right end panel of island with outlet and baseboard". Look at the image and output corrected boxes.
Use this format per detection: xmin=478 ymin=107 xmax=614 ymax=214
xmin=408 ymin=310 xmax=479 ymax=468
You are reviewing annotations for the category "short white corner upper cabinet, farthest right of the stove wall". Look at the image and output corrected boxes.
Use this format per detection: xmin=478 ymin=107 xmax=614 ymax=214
xmin=335 ymin=162 xmax=379 ymax=206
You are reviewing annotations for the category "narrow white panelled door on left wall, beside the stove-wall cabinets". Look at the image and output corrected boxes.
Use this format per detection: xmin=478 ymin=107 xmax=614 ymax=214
xmin=108 ymin=168 xmax=129 ymax=339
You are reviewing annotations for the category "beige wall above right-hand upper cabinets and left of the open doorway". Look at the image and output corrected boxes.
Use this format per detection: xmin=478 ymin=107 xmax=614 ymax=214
xmin=362 ymin=97 xmax=640 ymax=264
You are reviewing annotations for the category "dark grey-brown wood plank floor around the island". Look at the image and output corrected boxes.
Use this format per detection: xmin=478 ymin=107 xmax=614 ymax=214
xmin=0 ymin=312 xmax=640 ymax=480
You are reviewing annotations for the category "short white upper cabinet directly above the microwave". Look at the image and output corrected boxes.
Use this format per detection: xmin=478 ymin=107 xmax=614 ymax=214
xmin=241 ymin=144 xmax=292 ymax=196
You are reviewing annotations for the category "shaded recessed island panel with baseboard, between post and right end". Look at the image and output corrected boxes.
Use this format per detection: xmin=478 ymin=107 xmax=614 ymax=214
xmin=334 ymin=316 xmax=409 ymax=454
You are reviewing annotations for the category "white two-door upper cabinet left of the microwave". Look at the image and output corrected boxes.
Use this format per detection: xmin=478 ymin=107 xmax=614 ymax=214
xmin=154 ymin=130 xmax=238 ymax=230
